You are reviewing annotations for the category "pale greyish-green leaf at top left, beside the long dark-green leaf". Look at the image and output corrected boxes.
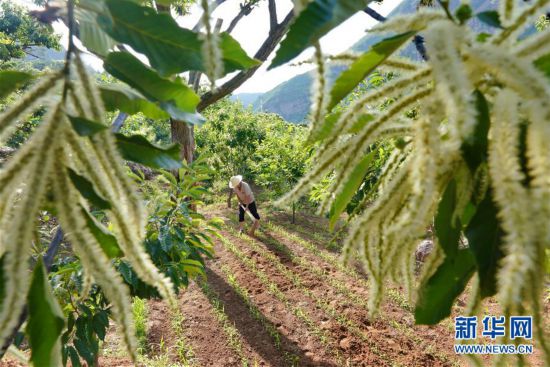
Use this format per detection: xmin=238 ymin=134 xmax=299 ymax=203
xmin=75 ymin=0 xmax=116 ymax=56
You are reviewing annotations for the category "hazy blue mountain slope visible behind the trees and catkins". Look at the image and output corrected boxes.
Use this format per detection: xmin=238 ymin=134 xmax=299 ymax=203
xmin=237 ymin=0 xmax=496 ymax=123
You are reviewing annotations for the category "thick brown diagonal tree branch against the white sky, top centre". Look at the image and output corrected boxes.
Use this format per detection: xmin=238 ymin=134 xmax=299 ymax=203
xmin=197 ymin=10 xmax=294 ymax=112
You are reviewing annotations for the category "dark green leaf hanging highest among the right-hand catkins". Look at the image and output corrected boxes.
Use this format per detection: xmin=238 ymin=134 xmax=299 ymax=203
xmin=461 ymin=90 xmax=490 ymax=173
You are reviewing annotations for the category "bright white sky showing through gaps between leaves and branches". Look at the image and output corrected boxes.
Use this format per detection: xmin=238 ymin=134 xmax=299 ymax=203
xmin=16 ymin=0 xmax=402 ymax=93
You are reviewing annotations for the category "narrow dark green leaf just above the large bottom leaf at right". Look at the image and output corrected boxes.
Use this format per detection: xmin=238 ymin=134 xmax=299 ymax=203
xmin=434 ymin=180 xmax=462 ymax=258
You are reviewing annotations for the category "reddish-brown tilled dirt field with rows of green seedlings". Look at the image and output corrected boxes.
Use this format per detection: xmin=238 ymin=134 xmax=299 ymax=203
xmin=97 ymin=206 xmax=549 ymax=367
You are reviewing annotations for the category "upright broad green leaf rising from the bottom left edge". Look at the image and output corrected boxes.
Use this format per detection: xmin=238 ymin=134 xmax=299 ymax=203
xmin=26 ymin=259 xmax=65 ymax=366
